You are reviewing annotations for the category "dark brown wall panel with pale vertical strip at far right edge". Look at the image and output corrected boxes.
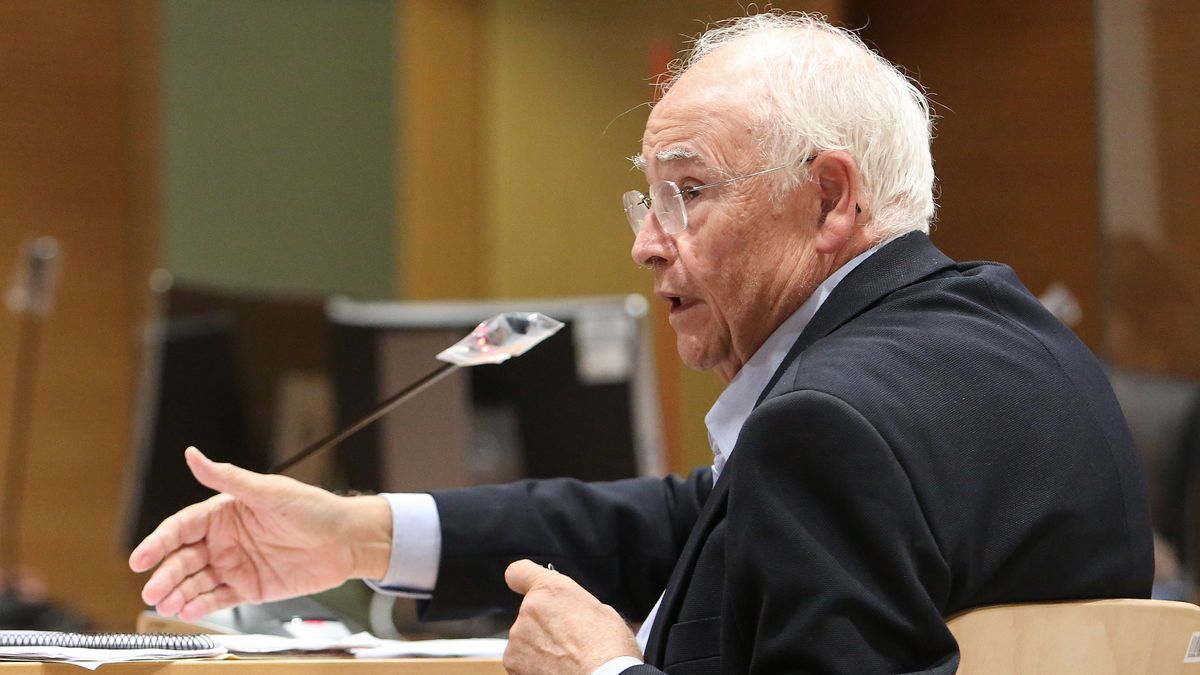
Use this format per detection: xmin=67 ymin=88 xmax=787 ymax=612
xmin=1100 ymin=0 xmax=1200 ymax=378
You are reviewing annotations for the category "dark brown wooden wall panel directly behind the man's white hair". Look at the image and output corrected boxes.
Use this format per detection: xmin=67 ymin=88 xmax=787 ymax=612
xmin=851 ymin=0 xmax=1102 ymax=350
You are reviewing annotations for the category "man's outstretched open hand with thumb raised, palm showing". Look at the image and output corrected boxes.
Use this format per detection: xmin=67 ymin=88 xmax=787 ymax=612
xmin=130 ymin=448 xmax=391 ymax=621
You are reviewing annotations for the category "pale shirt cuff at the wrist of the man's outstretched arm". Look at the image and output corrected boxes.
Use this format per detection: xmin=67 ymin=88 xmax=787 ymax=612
xmin=367 ymin=492 xmax=442 ymax=598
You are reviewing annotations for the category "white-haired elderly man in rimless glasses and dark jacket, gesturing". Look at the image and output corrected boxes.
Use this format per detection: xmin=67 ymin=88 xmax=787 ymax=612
xmin=130 ymin=13 xmax=1152 ymax=674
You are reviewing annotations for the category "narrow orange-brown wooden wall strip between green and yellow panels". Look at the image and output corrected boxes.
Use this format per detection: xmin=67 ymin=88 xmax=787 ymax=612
xmin=395 ymin=0 xmax=488 ymax=300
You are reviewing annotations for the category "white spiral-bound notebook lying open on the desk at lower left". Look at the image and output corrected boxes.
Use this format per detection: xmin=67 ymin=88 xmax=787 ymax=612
xmin=0 ymin=631 xmax=228 ymax=669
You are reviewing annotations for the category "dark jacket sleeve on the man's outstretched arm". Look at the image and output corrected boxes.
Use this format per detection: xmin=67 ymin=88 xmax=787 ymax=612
xmin=420 ymin=468 xmax=712 ymax=620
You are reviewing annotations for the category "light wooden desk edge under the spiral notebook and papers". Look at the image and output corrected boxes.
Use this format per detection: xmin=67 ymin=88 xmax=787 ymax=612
xmin=0 ymin=657 xmax=504 ymax=675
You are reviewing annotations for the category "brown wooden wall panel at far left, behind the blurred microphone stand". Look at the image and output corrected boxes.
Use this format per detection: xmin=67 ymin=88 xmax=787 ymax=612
xmin=0 ymin=0 xmax=152 ymax=628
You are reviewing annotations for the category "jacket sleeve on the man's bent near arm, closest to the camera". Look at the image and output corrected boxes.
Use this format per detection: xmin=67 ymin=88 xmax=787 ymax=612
xmin=721 ymin=390 xmax=959 ymax=674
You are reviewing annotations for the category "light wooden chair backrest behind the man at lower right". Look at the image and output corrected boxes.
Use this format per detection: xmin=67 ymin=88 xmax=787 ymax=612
xmin=947 ymin=599 xmax=1200 ymax=675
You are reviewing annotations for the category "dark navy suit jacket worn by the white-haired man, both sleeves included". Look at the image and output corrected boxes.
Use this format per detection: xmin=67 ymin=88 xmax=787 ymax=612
xmin=426 ymin=234 xmax=1153 ymax=674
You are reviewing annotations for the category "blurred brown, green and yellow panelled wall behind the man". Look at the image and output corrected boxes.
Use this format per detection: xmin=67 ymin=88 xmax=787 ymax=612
xmin=0 ymin=0 xmax=1200 ymax=629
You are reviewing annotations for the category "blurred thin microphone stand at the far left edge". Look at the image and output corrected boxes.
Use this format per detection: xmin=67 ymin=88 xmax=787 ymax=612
xmin=0 ymin=237 xmax=88 ymax=631
